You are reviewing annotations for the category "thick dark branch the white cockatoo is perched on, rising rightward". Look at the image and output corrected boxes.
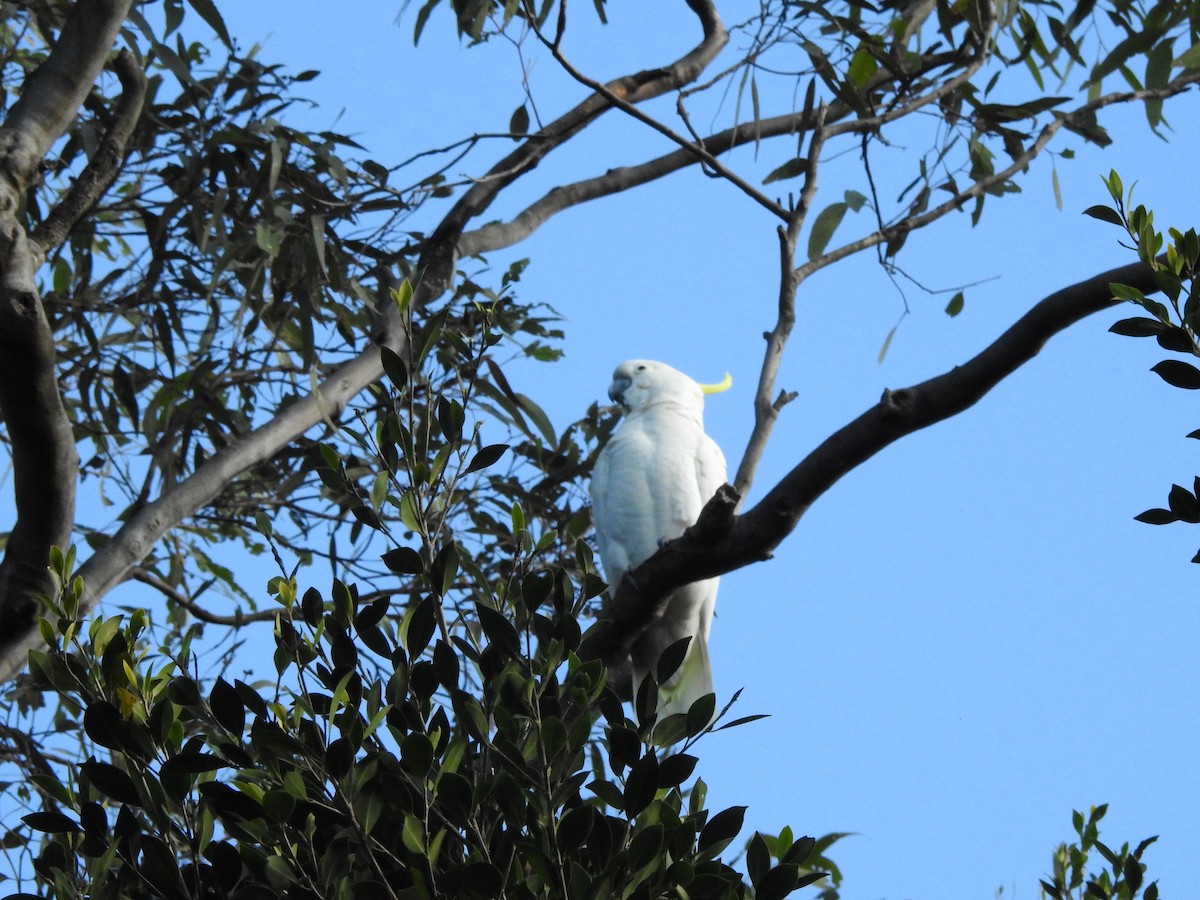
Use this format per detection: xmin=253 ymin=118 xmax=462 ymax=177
xmin=582 ymin=256 xmax=1158 ymax=664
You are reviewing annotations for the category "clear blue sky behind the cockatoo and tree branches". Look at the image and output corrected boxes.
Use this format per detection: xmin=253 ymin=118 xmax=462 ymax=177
xmin=175 ymin=0 xmax=1200 ymax=900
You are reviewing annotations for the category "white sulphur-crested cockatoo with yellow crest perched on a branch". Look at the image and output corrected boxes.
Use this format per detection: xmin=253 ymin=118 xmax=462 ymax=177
xmin=592 ymin=359 xmax=730 ymax=721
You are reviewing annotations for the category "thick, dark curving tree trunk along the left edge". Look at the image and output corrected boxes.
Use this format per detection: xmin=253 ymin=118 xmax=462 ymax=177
xmin=0 ymin=0 xmax=130 ymax=668
